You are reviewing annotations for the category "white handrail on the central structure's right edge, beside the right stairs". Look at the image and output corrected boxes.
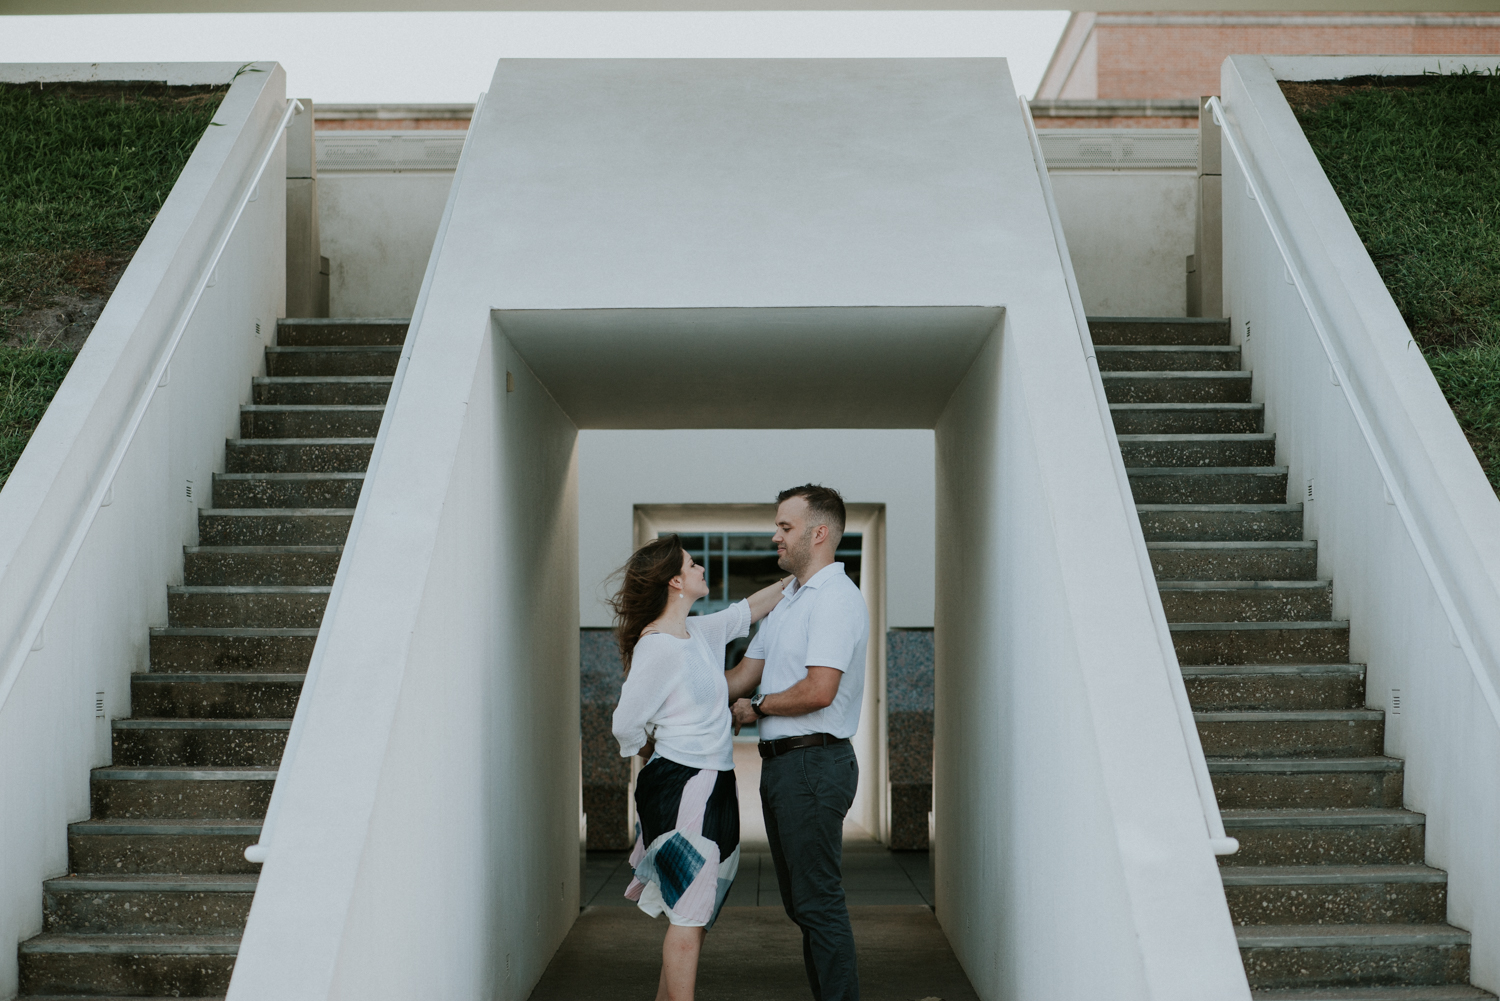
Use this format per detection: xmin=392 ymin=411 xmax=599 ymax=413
xmin=1020 ymin=98 xmax=1239 ymax=855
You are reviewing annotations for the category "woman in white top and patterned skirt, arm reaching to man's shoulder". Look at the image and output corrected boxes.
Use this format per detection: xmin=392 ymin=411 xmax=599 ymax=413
xmin=612 ymin=536 xmax=786 ymax=1001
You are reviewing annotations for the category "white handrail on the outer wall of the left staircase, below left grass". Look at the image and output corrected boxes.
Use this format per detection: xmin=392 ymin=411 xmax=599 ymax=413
xmin=0 ymin=99 xmax=303 ymax=708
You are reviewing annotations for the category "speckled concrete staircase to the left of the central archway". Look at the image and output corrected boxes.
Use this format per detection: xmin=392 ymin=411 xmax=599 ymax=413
xmin=20 ymin=320 xmax=407 ymax=998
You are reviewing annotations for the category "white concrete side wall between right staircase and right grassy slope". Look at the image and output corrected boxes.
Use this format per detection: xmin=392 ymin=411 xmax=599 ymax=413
xmin=1214 ymin=56 xmax=1500 ymax=989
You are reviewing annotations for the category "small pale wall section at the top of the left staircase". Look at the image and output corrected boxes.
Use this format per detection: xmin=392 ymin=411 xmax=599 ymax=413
xmin=318 ymin=170 xmax=453 ymax=317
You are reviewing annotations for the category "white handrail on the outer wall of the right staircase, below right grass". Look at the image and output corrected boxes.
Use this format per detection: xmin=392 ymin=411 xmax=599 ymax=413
xmin=1208 ymin=98 xmax=1500 ymax=726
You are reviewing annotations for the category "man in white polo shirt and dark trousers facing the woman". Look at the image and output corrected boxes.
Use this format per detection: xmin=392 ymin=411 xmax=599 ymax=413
xmin=729 ymin=483 xmax=870 ymax=1001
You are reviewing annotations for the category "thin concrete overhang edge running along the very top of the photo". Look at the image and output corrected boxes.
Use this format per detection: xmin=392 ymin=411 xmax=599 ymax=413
xmin=0 ymin=0 xmax=1500 ymax=15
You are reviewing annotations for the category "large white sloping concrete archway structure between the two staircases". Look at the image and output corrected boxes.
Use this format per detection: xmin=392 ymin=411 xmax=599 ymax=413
xmin=231 ymin=60 xmax=1245 ymax=1001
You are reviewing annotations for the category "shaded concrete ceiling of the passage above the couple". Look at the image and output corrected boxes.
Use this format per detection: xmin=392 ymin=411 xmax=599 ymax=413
xmin=492 ymin=306 xmax=1004 ymax=428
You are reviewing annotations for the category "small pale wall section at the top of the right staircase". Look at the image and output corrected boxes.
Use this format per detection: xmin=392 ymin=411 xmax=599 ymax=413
xmin=1049 ymin=170 xmax=1199 ymax=317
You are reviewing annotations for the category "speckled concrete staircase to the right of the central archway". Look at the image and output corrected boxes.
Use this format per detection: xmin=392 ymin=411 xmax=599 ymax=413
xmin=1089 ymin=318 xmax=1494 ymax=1001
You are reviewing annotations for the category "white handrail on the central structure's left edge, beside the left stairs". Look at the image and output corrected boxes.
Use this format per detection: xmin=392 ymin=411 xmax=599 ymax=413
xmin=245 ymin=93 xmax=485 ymax=863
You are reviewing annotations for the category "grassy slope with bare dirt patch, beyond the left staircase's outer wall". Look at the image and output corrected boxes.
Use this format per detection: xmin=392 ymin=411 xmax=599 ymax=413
xmin=0 ymin=84 xmax=224 ymax=485
